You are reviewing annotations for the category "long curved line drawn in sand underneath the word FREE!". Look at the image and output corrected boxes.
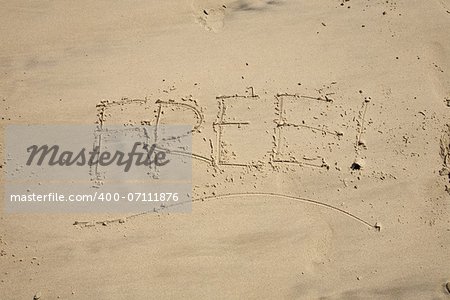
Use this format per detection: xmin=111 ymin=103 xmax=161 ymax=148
xmin=73 ymin=192 xmax=380 ymax=231
